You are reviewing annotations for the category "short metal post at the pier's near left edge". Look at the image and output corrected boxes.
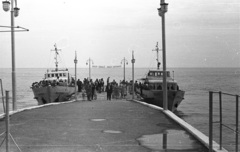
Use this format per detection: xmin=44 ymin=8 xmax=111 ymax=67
xmin=5 ymin=91 xmax=10 ymax=152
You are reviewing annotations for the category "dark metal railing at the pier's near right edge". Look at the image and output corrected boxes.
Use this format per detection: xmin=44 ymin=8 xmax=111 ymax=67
xmin=209 ymin=91 xmax=240 ymax=152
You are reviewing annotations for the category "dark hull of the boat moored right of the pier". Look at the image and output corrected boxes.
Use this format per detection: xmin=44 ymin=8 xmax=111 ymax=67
xmin=137 ymin=89 xmax=185 ymax=112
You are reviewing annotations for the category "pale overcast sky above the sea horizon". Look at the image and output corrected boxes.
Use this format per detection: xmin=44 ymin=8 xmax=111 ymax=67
xmin=0 ymin=0 xmax=240 ymax=68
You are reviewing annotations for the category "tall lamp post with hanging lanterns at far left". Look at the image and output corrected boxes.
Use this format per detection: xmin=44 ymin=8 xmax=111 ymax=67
xmin=2 ymin=0 xmax=20 ymax=110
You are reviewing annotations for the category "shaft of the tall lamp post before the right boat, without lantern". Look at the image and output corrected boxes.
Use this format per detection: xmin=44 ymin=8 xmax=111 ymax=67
xmin=161 ymin=0 xmax=168 ymax=110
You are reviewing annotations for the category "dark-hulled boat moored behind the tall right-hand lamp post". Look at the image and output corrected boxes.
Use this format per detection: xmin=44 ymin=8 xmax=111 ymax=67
xmin=136 ymin=44 xmax=185 ymax=112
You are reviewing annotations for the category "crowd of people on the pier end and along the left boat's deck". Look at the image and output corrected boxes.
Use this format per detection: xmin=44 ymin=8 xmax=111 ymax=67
xmin=32 ymin=77 xmax=137 ymax=101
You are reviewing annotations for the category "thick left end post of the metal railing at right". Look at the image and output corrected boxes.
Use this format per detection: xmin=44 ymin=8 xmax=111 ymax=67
xmin=209 ymin=91 xmax=213 ymax=152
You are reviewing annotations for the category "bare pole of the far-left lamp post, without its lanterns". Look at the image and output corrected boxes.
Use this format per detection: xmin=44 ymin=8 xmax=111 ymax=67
xmin=11 ymin=0 xmax=17 ymax=110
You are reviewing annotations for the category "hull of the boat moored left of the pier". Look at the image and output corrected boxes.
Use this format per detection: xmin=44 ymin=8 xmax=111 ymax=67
xmin=32 ymin=86 xmax=75 ymax=105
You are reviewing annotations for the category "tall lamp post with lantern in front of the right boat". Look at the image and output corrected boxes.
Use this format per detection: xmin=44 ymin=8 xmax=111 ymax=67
xmin=158 ymin=0 xmax=168 ymax=110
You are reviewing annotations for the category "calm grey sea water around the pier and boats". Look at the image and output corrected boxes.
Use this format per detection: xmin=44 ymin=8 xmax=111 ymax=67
xmin=0 ymin=68 xmax=240 ymax=151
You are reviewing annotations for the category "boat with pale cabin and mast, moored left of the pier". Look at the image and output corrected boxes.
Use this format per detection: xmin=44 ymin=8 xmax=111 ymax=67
xmin=31 ymin=44 xmax=75 ymax=105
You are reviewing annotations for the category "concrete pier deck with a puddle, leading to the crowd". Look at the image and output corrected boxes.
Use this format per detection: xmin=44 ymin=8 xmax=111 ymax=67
xmin=0 ymin=95 xmax=208 ymax=152
